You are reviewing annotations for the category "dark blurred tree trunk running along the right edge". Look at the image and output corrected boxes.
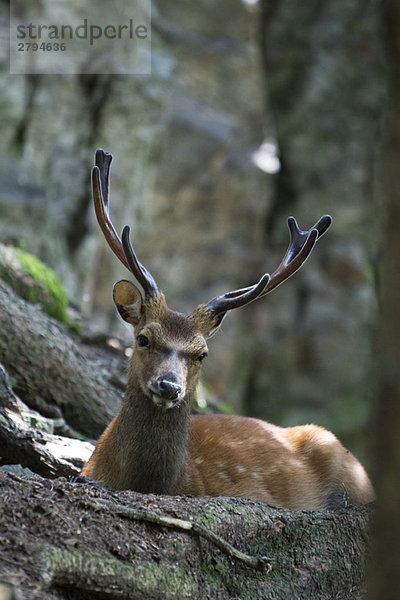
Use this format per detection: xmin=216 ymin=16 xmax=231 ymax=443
xmin=369 ymin=0 xmax=400 ymax=600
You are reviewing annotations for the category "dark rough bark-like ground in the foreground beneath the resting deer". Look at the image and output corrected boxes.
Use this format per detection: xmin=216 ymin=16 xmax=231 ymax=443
xmin=0 ymin=473 xmax=369 ymax=600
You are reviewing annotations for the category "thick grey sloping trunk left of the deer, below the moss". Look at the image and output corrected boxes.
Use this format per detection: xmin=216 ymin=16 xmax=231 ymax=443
xmin=0 ymin=282 xmax=122 ymax=437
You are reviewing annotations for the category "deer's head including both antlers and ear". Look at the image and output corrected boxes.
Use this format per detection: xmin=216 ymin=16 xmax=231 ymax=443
xmin=92 ymin=150 xmax=331 ymax=409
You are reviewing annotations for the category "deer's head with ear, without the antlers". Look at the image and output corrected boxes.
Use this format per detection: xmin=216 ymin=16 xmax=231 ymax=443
xmin=114 ymin=281 xmax=211 ymax=409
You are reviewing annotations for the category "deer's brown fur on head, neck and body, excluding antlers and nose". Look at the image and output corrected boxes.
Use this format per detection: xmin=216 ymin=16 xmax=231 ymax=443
xmin=82 ymin=282 xmax=374 ymax=509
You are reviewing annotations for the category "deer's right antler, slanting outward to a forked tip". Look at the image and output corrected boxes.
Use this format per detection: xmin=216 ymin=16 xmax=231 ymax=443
xmin=204 ymin=215 xmax=332 ymax=316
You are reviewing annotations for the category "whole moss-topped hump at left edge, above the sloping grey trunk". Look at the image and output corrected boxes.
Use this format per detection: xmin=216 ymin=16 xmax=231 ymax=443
xmin=0 ymin=244 xmax=74 ymax=327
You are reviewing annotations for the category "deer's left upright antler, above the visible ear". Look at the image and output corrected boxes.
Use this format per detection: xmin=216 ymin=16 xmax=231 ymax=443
xmin=92 ymin=149 xmax=159 ymax=299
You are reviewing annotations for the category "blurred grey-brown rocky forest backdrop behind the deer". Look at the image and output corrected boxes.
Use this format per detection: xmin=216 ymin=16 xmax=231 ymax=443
xmin=0 ymin=0 xmax=388 ymax=464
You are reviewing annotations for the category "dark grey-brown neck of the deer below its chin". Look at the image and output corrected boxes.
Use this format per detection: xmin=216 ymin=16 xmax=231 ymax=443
xmin=118 ymin=389 xmax=191 ymax=494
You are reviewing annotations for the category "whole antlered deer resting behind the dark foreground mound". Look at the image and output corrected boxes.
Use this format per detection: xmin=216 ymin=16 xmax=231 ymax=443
xmin=81 ymin=149 xmax=374 ymax=510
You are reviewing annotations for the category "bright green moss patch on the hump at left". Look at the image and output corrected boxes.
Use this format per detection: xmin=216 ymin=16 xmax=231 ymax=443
xmin=14 ymin=248 xmax=73 ymax=326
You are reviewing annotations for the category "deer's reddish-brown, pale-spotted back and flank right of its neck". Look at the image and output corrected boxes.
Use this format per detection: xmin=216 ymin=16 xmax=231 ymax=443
xmin=177 ymin=415 xmax=374 ymax=509
